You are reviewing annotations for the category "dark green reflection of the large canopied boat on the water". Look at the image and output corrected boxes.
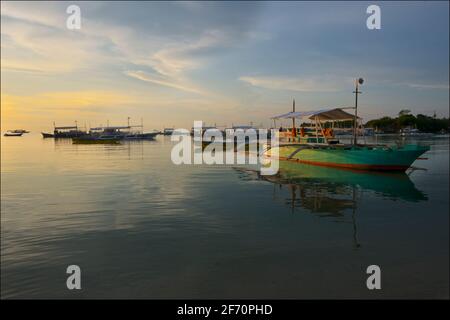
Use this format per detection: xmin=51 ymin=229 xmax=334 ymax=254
xmin=235 ymin=161 xmax=428 ymax=248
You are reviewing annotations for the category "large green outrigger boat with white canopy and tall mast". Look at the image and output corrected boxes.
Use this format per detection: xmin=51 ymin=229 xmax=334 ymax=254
xmin=265 ymin=79 xmax=430 ymax=171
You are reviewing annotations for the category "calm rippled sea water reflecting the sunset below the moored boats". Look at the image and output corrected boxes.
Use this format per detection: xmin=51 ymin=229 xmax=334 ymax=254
xmin=1 ymin=133 xmax=449 ymax=298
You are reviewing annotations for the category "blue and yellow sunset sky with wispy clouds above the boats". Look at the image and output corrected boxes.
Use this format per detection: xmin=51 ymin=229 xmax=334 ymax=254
xmin=1 ymin=1 xmax=449 ymax=131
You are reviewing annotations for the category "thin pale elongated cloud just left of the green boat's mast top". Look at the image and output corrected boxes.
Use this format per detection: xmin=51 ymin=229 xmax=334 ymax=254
xmin=239 ymin=76 xmax=341 ymax=92
